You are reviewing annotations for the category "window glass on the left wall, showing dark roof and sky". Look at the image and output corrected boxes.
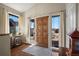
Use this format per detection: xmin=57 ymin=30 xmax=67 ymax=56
xmin=9 ymin=14 xmax=19 ymax=34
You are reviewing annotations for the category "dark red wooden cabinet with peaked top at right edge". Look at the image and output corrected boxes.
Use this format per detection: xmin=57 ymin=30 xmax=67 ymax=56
xmin=69 ymin=29 xmax=79 ymax=56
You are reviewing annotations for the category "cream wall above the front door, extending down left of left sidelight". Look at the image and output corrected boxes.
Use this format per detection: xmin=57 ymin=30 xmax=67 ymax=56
xmin=24 ymin=3 xmax=65 ymax=43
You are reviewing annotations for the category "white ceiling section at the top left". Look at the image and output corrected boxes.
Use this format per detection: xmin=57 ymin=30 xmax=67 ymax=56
xmin=4 ymin=3 xmax=36 ymax=12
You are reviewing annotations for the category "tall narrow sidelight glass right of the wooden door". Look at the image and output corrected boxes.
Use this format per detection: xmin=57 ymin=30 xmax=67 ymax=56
xmin=52 ymin=15 xmax=60 ymax=49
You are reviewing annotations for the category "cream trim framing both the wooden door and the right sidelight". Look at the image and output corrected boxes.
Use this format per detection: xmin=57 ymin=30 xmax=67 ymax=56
xmin=29 ymin=10 xmax=66 ymax=48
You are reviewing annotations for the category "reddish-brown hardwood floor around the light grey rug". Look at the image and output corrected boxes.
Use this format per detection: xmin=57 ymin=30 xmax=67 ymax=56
xmin=11 ymin=44 xmax=58 ymax=56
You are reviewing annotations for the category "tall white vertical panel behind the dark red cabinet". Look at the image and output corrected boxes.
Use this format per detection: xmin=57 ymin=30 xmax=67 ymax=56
xmin=66 ymin=3 xmax=76 ymax=48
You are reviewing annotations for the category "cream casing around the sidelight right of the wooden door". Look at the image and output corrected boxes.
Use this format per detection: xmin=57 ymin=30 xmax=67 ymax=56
xmin=48 ymin=11 xmax=65 ymax=48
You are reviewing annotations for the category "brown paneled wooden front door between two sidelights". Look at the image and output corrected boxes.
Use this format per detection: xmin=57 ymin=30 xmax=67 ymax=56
xmin=36 ymin=16 xmax=48 ymax=47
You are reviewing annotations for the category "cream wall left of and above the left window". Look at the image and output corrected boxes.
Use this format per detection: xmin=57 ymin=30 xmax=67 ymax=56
xmin=0 ymin=3 xmax=22 ymax=34
